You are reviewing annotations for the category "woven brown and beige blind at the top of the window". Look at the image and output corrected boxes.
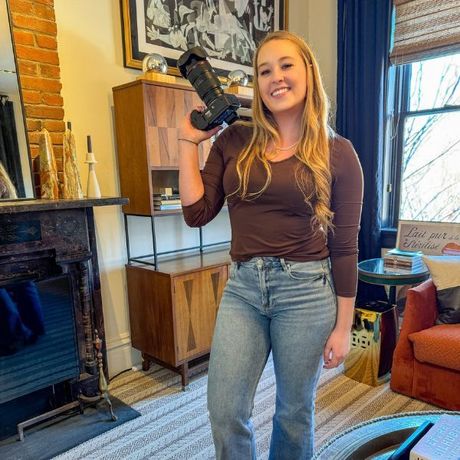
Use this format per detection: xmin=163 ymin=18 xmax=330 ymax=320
xmin=390 ymin=0 xmax=460 ymax=64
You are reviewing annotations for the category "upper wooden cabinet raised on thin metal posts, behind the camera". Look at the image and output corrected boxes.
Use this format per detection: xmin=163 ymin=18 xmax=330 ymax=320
xmin=113 ymin=80 xmax=210 ymax=216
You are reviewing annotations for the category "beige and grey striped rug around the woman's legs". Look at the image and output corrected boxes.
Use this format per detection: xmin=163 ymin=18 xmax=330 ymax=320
xmin=55 ymin=361 xmax=437 ymax=460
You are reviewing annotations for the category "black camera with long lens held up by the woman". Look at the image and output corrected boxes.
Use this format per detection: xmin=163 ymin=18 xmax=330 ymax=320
xmin=177 ymin=46 xmax=240 ymax=131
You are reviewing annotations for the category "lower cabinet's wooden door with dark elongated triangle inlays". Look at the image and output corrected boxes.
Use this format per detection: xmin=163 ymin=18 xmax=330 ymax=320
xmin=173 ymin=265 xmax=227 ymax=362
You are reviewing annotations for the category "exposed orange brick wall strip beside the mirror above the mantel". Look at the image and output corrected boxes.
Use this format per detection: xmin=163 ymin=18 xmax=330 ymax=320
xmin=9 ymin=0 xmax=65 ymax=197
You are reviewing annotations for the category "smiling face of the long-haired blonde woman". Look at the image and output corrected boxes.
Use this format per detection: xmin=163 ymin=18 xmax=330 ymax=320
xmin=257 ymin=40 xmax=307 ymax=118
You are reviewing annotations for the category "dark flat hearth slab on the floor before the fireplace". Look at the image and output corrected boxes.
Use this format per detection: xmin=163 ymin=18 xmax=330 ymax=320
xmin=0 ymin=397 xmax=141 ymax=460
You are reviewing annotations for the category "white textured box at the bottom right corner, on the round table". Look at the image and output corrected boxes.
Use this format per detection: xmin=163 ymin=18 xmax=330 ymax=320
xmin=409 ymin=414 xmax=460 ymax=460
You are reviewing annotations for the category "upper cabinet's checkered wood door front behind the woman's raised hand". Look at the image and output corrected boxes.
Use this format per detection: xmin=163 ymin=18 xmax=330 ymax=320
xmin=145 ymin=85 xmax=210 ymax=169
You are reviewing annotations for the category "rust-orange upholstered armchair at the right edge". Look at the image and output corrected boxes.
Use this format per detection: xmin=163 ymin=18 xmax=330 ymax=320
xmin=390 ymin=279 xmax=460 ymax=410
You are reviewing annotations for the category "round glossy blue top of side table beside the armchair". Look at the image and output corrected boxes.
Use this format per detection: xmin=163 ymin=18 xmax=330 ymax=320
xmin=358 ymin=258 xmax=430 ymax=286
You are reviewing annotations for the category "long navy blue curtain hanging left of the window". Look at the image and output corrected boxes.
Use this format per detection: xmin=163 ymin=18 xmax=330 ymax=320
xmin=336 ymin=0 xmax=392 ymax=300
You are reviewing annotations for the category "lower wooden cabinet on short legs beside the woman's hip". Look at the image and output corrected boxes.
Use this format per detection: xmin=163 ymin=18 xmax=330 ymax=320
xmin=126 ymin=251 xmax=230 ymax=387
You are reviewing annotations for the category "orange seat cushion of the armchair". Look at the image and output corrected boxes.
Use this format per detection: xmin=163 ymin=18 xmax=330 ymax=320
xmin=408 ymin=324 xmax=460 ymax=371
